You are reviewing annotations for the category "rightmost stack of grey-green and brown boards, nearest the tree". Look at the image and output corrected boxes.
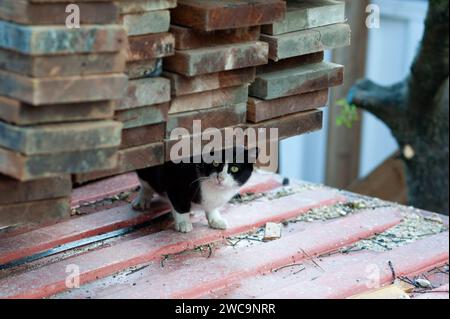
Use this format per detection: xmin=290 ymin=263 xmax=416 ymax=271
xmin=247 ymin=0 xmax=350 ymax=139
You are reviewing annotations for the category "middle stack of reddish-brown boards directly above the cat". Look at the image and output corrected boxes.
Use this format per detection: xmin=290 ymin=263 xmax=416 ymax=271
xmin=164 ymin=0 xmax=286 ymax=160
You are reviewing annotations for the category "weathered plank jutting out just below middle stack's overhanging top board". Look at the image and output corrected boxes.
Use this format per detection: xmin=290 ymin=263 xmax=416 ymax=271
xmin=164 ymin=41 xmax=268 ymax=76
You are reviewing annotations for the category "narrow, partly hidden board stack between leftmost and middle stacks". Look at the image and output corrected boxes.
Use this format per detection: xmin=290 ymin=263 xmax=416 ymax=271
xmin=74 ymin=0 xmax=177 ymax=184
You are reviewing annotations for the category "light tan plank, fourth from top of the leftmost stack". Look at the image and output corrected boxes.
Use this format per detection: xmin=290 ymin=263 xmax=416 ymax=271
xmin=0 ymin=70 xmax=128 ymax=105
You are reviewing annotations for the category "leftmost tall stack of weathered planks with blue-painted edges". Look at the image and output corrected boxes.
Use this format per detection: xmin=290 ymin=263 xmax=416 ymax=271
xmin=0 ymin=0 xmax=127 ymax=228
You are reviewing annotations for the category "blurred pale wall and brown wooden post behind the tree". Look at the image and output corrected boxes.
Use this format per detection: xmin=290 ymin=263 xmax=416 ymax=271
xmin=280 ymin=0 xmax=428 ymax=203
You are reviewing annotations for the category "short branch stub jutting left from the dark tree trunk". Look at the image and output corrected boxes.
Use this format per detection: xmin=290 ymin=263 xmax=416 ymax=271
xmin=347 ymin=79 xmax=407 ymax=130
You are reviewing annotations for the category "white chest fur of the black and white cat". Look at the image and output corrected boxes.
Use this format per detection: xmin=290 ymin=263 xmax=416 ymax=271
xmin=200 ymin=183 xmax=239 ymax=212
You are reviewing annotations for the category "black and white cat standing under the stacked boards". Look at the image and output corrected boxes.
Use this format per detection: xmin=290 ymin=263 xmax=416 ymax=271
xmin=133 ymin=148 xmax=258 ymax=233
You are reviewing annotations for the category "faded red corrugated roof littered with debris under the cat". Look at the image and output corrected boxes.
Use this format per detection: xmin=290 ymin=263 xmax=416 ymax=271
xmin=0 ymin=174 xmax=449 ymax=298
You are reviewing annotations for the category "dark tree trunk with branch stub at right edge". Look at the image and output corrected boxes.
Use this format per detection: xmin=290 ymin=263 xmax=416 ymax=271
xmin=348 ymin=0 xmax=449 ymax=215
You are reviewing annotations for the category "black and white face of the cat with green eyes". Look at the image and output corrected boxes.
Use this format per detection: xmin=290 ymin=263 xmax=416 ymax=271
xmin=197 ymin=150 xmax=257 ymax=189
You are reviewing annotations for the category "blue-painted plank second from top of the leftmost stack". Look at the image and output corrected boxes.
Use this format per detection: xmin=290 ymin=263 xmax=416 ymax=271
xmin=0 ymin=20 xmax=127 ymax=55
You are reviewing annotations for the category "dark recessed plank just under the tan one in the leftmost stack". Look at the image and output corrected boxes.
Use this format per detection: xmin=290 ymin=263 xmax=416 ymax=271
xmin=0 ymin=96 xmax=116 ymax=125
